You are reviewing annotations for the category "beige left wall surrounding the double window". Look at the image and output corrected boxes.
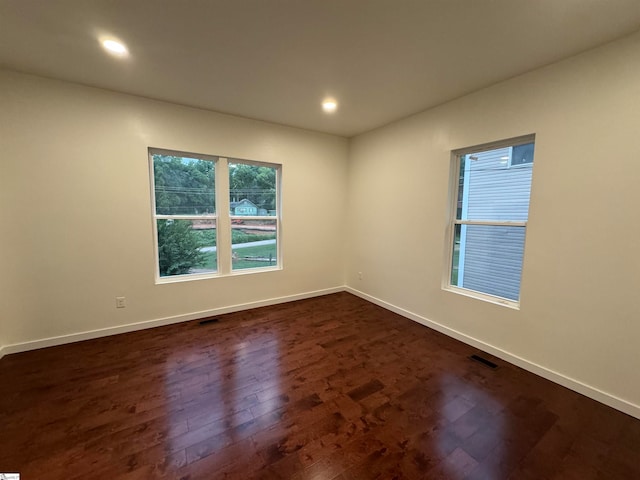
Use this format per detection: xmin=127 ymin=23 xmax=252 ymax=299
xmin=0 ymin=72 xmax=348 ymax=346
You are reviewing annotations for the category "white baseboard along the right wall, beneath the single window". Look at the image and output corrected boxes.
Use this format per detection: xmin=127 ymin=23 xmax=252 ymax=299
xmin=345 ymin=287 xmax=640 ymax=419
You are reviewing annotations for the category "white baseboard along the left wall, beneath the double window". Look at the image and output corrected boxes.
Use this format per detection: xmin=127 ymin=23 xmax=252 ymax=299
xmin=0 ymin=286 xmax=344 ymax=358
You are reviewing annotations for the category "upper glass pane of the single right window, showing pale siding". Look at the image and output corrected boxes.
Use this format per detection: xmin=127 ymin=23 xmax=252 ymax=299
xmin=457 ymin=144 xmax=533 ymax=221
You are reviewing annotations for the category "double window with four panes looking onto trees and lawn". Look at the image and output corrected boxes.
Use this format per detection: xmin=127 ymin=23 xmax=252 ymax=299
xmin=149 ymin=149 xmax=280 ymax=282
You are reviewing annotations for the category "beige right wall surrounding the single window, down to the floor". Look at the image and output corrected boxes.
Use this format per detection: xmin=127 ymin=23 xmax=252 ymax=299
xmin=346 ymin=31 xmax=640 ymax=415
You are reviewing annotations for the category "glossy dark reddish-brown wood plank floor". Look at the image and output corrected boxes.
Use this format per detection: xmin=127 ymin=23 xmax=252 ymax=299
xmin=0 ymin=293 xmax=640 ymax=480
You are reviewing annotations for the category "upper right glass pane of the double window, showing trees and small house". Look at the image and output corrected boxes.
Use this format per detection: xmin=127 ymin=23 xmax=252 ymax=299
xmin=229 ymin=162 xmax=277 ymax=217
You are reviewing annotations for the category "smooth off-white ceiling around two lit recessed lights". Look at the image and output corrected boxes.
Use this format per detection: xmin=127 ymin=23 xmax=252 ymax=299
xmin=0 ymin=0 xmax=640 ymax=137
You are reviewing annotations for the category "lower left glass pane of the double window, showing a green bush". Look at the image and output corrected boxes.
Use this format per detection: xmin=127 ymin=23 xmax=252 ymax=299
xmin=157 ymin=219 xmax=218 ymax=277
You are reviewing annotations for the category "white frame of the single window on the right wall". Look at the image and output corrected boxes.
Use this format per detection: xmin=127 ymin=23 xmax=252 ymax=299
xmin=442 ymin=134 xmax=535 ymax=309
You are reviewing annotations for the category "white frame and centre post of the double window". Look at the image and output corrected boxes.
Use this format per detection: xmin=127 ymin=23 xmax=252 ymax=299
xmin=148 ymin=147 xmax=283 ymax=284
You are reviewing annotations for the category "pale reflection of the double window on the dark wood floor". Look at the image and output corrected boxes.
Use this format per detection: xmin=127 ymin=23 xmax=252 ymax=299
xmin=165 ymin=327 xmax=282 ymax=466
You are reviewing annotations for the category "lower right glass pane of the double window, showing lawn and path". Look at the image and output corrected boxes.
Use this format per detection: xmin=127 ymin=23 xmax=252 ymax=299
xmin=231 ymin=217 xmax=278 ymax=270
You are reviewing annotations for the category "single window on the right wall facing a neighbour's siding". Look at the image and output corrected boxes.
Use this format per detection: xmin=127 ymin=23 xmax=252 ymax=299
xmin=445 ymin=135 xmax=534 ymax=305
